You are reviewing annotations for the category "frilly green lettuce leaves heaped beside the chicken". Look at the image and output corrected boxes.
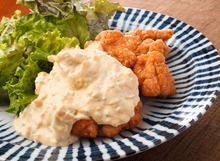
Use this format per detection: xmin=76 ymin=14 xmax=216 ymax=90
xmin=0 ymin=0 xmax=124 ymax=116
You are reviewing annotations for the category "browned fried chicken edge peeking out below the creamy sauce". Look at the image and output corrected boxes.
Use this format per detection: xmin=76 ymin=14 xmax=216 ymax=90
xmin=71 ymin=101 xmax=143 ymax=138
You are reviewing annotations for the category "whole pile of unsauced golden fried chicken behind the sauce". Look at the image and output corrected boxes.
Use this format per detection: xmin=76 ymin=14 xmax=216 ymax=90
xmin=87 ymin=29 xmax=176 ymax=97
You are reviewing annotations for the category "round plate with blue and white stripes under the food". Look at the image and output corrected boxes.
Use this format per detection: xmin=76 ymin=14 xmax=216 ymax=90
xmin=0 ymin=8 xmax=220 ymax=160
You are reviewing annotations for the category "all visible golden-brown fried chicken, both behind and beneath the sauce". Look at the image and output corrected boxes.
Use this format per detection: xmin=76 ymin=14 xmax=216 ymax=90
xmin=71 ymin=29 xmax=176 ymax=138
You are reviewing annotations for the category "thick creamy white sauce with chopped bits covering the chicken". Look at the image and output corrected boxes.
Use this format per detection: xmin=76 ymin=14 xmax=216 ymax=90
xmin=13 ymin=44 xmax=140 ymax=146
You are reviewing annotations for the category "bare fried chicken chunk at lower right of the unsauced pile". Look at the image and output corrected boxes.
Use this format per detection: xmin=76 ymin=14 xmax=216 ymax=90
xmin=133 ymin=51 xmax=176 ymax=97
